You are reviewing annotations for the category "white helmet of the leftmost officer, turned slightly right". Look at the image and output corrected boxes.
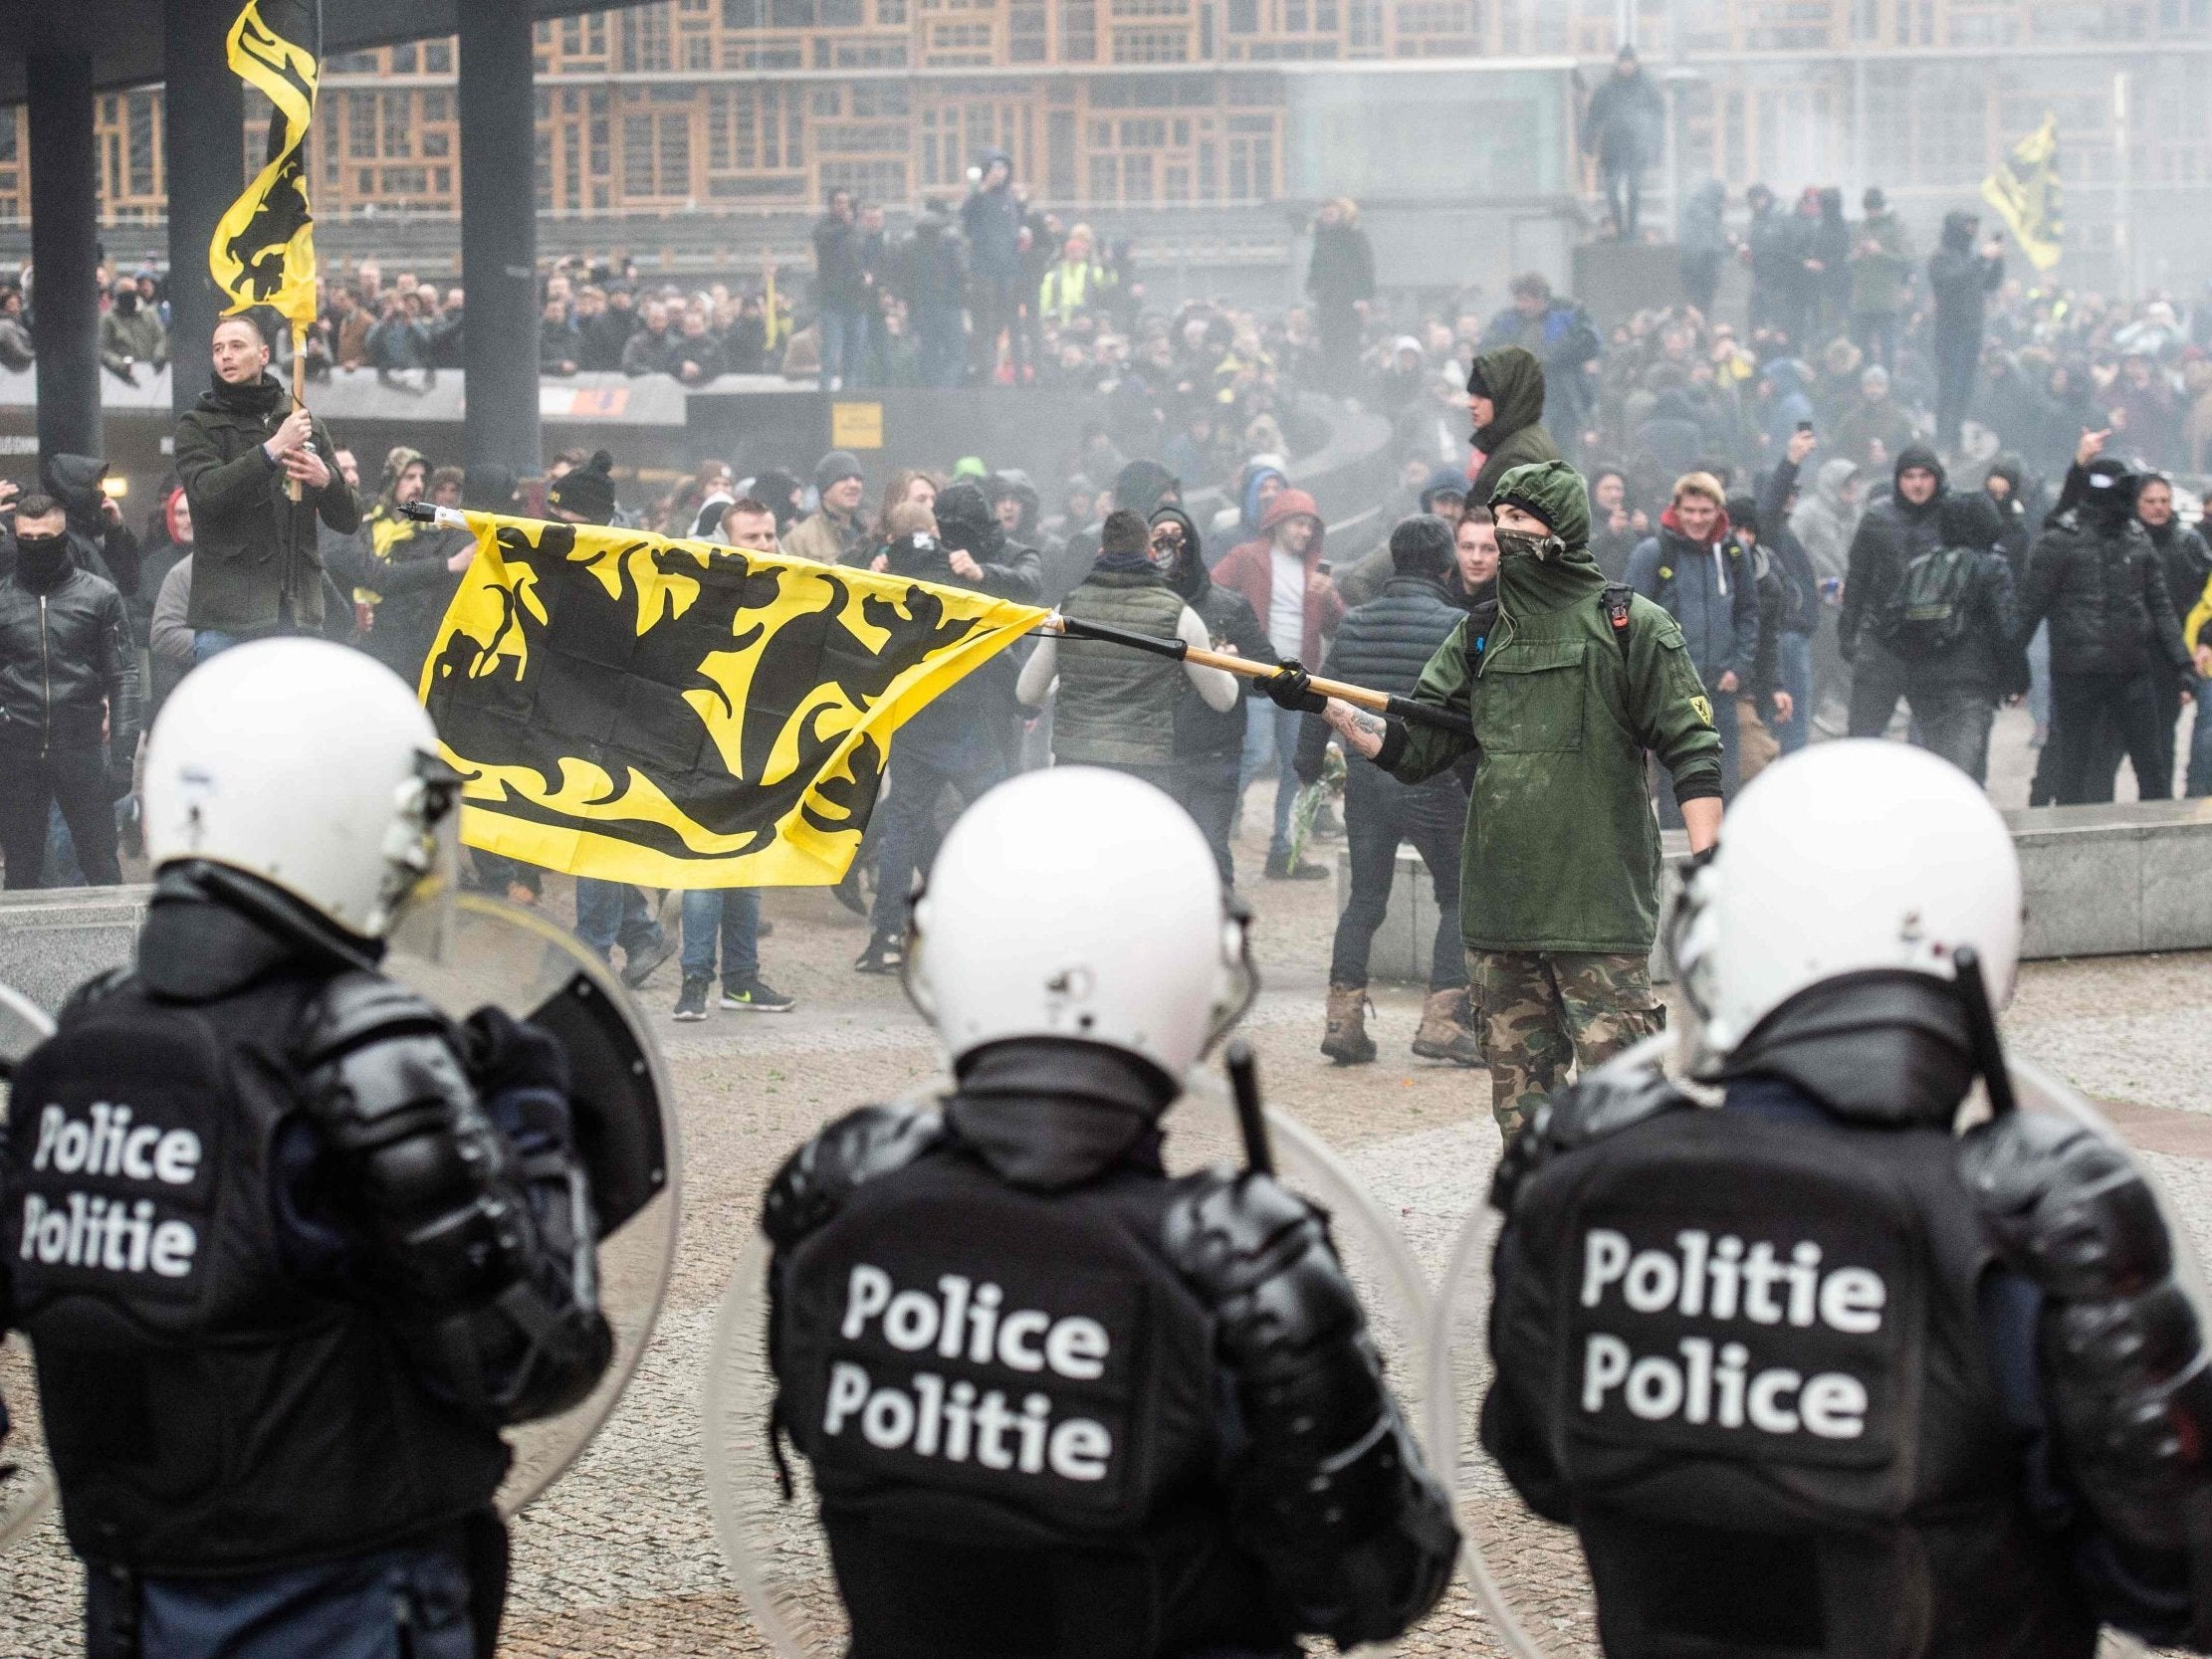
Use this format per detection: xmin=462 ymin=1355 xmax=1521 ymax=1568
xmin=146 ymin=639 xmax=458 ymax=937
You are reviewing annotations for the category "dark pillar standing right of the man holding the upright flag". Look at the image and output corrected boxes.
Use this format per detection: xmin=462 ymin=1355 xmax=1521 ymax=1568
xmin=460 ymin=0 xmax=545 ymax=476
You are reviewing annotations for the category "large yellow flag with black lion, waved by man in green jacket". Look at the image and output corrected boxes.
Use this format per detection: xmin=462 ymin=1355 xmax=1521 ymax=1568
xmin=420 ymin=514 xmax=1046 ymax=887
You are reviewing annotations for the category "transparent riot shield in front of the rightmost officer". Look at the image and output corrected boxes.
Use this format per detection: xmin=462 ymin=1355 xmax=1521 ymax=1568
xmin=1427 ymin=1031 xmax=2176 ymax=1659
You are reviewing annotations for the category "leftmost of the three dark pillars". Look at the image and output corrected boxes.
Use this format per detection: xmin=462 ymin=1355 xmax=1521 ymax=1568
xmin=24 ymin=53 xmax=102 ymax=469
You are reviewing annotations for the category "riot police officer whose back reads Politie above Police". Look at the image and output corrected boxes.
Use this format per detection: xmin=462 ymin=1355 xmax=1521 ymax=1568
xmin=1482 ymin=741 xmax=2212 ymax=1659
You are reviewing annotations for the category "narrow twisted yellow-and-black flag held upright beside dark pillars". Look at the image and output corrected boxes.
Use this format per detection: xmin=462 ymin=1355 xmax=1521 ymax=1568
xmin=208 ymin=0 xmax=323 ymax=340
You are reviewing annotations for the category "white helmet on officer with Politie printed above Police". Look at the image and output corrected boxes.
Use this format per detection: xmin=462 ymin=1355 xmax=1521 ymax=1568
xmin=1667 ymin=738 xmax=2020 ymax=1071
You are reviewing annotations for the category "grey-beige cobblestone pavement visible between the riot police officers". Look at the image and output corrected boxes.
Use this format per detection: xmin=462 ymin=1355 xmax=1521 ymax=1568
xmin=0 ymin=813 xmax=2212 ymax=1659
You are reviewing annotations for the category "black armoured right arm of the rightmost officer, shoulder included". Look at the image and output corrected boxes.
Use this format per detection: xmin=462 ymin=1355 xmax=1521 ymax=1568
xmin=1960 ymin=1113 xmax=2212 ymax=1556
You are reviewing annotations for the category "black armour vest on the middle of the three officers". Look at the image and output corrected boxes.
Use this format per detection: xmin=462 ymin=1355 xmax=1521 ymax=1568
xmin=776 ymin=1148 xmax=1294 ymax=1659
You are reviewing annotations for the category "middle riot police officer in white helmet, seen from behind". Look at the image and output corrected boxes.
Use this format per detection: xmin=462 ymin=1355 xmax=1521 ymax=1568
xmin=764 ymin=767 xmax=1457 ymax=1659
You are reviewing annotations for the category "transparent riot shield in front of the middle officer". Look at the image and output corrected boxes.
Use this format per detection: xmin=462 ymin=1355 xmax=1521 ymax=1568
xmin=699 ymin=1071 xmax=1453 ymax=1659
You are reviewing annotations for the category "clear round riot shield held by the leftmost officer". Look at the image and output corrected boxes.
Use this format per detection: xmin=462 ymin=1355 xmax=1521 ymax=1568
xmin=385 ymin=894 xmax=679 ymax=1516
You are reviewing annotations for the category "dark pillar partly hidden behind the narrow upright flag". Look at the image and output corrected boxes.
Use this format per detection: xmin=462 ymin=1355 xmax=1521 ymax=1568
xmin=161 ymin=0 xmax=246 ymax=414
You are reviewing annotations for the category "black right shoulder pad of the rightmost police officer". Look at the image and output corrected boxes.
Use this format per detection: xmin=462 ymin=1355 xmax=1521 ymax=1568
xmin=1957 ymin=1111 xmax=2172 ymax=1301
